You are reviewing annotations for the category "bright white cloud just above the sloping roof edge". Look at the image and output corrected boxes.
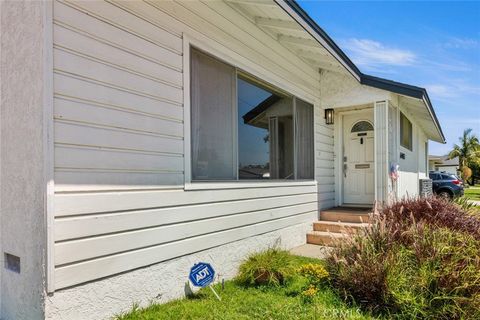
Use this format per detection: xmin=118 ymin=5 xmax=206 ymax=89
xmin=341 ymin=38 xmax=417 ymax=70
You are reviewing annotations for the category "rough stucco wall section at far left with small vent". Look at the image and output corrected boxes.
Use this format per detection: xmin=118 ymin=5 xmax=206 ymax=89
xmin=0 ymin=1 xmax=48 ymax=320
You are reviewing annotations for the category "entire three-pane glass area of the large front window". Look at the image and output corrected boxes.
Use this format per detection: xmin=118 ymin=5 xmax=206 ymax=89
xmin=191 ymin=49 xmax=314 ymax=181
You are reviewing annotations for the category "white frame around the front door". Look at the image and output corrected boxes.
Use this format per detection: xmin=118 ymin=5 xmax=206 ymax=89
xmin=333 ymin=105 xmax=376 ymax=207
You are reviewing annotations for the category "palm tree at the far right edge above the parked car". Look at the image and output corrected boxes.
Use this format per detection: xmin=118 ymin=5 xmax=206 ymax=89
xmin=448 ymin=129 xmax=480 ymax=180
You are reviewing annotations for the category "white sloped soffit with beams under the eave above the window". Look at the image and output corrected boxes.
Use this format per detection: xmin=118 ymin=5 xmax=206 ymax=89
xmin=224 ymin=0 xmax=351 ymax=75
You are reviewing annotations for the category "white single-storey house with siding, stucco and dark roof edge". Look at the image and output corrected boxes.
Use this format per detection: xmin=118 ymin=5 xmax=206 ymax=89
xmin=0 ymin=0 xmax=445 ymax=319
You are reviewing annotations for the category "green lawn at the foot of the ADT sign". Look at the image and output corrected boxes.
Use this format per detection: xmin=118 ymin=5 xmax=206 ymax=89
xmin=117 ymin=256 xmax=374 ymax=320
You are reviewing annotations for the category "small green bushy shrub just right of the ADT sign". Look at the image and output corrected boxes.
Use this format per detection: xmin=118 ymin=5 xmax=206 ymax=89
xmin=236 ymin=248 xmax=295 ymax=286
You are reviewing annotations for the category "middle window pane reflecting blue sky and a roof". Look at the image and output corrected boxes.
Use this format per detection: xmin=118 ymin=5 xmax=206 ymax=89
xmin=238 ymin=78 xmax=294 ymax=179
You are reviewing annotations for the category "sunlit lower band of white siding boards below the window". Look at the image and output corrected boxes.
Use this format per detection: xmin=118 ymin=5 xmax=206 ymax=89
xmin=55 ymin=183 xmax=318 ymax=289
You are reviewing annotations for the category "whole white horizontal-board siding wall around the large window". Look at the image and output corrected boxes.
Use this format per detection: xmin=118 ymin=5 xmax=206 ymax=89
xmin=54 ymin=1 xmax=334 ymax=289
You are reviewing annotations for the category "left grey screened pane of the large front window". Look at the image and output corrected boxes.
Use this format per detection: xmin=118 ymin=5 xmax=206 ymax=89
xmin=191 ymin=50 xmax=236 ymax=180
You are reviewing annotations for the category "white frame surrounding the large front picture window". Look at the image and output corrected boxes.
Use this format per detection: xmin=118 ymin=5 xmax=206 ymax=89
xmin=183 ymin=34 xmax=318 ymax=190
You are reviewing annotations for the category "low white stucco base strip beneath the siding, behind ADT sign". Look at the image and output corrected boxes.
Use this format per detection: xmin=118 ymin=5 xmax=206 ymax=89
xmin=46 ymin=223 xmax=312 ymax=320
